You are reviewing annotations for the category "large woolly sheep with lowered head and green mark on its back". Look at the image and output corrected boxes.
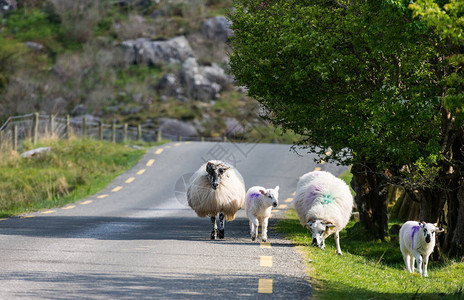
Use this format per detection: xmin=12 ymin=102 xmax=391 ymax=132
xmin=293 ymin=171 xmax=353 ymax=255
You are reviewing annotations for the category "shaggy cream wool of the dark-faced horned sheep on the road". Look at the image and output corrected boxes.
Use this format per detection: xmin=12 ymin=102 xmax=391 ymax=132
xmin=187 ymin=160 xmax=245 ymax=221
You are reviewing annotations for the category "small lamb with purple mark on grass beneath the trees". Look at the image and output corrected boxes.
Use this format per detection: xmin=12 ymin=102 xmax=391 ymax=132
xmin=400 ymin=221 xmax=443 ymax=277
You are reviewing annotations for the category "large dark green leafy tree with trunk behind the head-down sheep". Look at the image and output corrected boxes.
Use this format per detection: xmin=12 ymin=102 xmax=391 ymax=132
xmin=229 ymin=0 xmax=445 ymax=238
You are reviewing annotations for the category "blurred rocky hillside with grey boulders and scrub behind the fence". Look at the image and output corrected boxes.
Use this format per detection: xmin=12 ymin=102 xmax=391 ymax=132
xmin=0 ymin=0 xmax=298 ymax=142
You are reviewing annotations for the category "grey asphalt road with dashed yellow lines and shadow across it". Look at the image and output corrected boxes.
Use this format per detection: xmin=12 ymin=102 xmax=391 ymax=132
xmin=0 ymin=142 xmax=346 ymax=299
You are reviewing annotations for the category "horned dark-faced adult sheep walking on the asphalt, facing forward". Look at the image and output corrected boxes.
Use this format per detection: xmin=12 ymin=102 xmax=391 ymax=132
xmin=187 ymin=160 xmax=245 ymax=240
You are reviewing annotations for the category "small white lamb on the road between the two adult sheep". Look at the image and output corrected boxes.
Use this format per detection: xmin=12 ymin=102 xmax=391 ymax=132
xmin=245 ymin=186 xmax=279 ymax=242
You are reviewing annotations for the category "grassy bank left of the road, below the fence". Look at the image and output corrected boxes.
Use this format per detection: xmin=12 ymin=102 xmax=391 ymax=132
xmin=0 ymin=139 xmax=150 ymax=217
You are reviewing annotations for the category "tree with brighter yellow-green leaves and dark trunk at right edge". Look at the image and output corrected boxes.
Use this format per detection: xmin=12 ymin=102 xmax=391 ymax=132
xmin=410 ymin=0 xmax=464 ymax=256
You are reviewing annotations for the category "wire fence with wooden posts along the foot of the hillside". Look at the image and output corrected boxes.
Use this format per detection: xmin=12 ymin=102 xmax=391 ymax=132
xmin=0 ymin=113 xmax=226 ymax=151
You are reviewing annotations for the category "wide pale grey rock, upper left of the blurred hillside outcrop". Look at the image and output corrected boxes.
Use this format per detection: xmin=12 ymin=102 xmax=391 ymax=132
xmin=122 ymin=36 xmax=194 ymax=65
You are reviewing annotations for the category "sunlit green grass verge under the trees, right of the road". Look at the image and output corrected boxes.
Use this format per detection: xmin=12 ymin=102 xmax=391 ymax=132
xmin=275 ymin=176 xmax=464 ymax=299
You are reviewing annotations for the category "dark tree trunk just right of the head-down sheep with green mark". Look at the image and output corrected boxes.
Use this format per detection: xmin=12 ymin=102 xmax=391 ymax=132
xmin=351 ymin=164 xmax=388 ymax=240
